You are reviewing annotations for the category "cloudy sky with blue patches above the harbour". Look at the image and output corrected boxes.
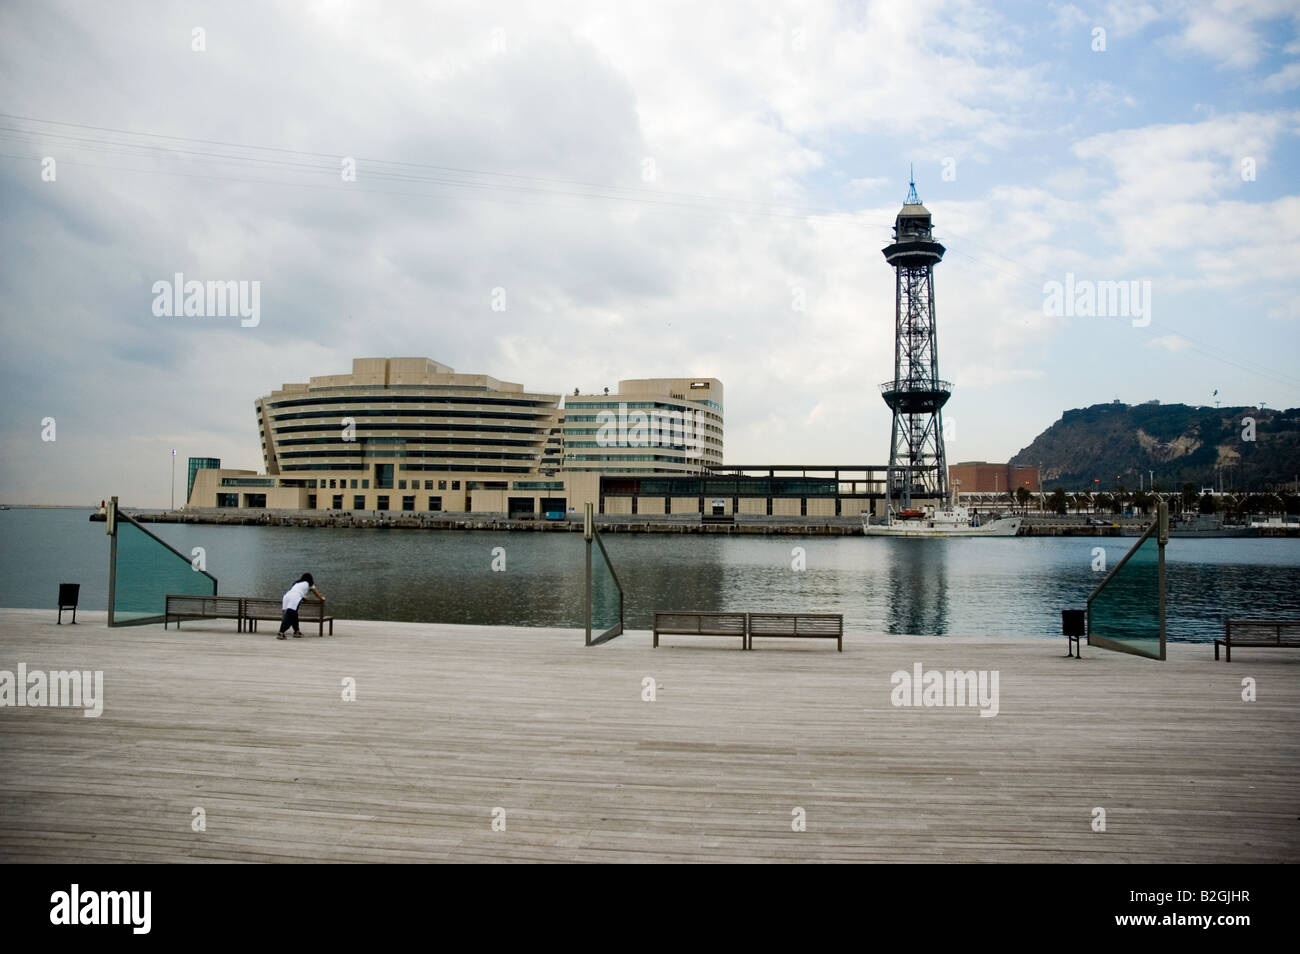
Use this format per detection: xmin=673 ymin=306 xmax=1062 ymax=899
xmin=0 ymin=0 xmax=1300 ymax=506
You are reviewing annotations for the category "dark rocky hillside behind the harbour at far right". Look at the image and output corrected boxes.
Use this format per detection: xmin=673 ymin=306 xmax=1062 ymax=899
xmin=1011 ymin=403 xmax=1300 ymax=490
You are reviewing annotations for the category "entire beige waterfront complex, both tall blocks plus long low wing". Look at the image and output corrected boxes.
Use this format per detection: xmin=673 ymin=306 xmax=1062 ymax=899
xmin=189 ymin=357 xmax=885 ymax=519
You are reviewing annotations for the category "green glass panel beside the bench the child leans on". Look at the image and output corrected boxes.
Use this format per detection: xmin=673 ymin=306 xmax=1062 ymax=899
xmin=112 ymin=517 xmax=217 ymax=624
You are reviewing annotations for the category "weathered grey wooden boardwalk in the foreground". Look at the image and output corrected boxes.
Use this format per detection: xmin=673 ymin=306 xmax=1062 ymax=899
xmin=0 ymin=610 xmax=1300 ymax=862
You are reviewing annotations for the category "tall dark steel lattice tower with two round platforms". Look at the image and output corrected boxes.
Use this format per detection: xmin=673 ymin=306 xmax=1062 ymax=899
xmin=880 ymin=174 xmax=953 ymax=509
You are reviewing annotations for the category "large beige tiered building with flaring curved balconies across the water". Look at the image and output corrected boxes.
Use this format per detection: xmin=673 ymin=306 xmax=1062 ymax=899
xmin=190 ymin=357 xmax=563 ymax=512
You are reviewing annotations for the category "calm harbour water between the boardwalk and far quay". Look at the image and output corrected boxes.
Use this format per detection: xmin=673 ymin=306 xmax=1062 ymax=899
xmin=0 ymin=509 xmax=1300 ymax=641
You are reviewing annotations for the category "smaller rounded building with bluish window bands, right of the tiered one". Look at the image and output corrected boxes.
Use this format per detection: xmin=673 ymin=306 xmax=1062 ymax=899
xmin=560 ymin=378 xmax=723 ymax=474
